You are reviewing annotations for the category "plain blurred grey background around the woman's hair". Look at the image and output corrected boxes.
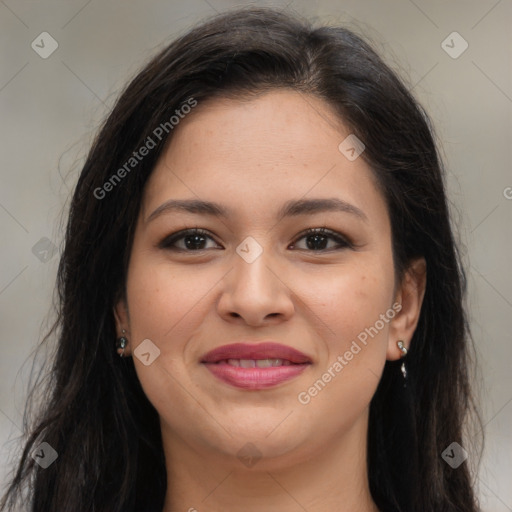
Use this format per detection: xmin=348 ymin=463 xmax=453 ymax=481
xmin=0 ymin=0 xmax=512 ymax=512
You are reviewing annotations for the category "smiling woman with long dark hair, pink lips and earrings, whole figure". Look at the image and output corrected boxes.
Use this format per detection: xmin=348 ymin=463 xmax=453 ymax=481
xmin=2 ymin=9 xmax=478 ymax=512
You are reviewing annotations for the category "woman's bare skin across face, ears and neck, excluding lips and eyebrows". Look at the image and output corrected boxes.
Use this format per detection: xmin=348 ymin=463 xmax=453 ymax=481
xmin=114 ymin=90 xmax=426 ymax=512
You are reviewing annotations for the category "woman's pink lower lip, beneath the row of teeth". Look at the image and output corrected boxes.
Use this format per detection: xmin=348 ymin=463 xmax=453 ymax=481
xmin=205 ymin=363 xmax=309 ymax=389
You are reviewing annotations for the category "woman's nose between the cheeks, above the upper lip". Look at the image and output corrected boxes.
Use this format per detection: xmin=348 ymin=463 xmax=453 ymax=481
xmin=217 ymin=246 xmax=295 ymax=327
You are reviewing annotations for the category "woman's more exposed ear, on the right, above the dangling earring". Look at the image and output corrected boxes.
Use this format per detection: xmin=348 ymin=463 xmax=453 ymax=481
xmin=386 ymin=258 xmax=427 ymax=361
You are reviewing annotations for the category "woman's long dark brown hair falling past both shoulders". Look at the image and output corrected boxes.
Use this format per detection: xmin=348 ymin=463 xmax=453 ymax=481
xmin=0 ymin=8 xmax=478 ymax=512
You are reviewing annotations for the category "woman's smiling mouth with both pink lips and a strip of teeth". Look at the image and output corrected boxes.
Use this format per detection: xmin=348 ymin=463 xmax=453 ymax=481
xmin=201 ymin=342 xmax=312 ymax=390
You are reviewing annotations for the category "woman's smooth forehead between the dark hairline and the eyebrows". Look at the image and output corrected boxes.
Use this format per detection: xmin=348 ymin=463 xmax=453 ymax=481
xmin=143 ymin=90 xmax=383 ymax=224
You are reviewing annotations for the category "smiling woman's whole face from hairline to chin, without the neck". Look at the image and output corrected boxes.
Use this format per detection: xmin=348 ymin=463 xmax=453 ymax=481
xmin=116 ymin=91 xmax=424 ymax=463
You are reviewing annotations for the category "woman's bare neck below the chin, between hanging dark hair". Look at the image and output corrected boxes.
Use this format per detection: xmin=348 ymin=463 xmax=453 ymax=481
xmin=162 ymin=412 xmax=378 ymax=512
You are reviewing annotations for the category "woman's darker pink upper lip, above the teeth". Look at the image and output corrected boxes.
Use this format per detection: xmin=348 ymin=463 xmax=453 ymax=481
xmin=201 ymin=342 xmax=311 ymax=364
